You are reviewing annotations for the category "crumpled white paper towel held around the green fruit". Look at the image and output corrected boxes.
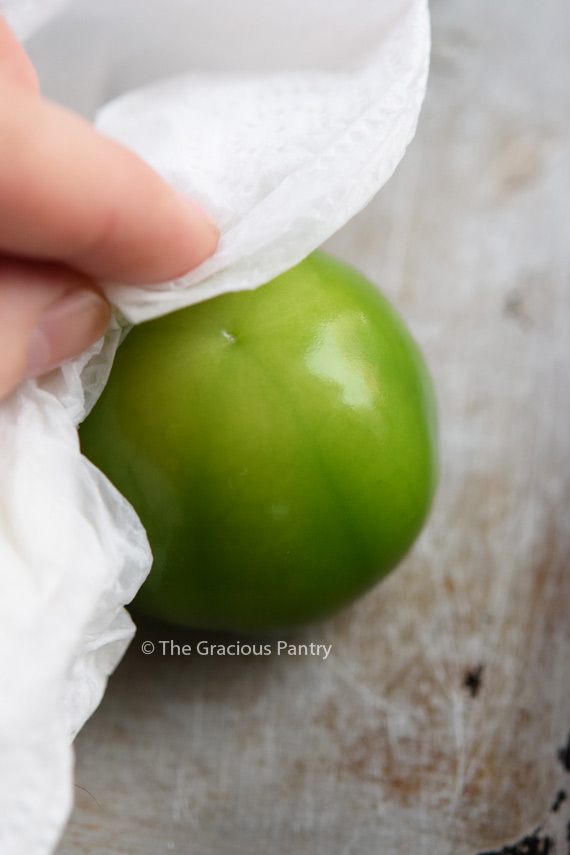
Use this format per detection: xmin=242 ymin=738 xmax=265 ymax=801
xmin=0 ymin=0 xmax=429 ymax=855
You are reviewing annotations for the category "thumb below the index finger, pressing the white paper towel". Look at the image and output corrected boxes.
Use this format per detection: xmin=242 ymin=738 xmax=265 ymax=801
xmin=0 ymin=258 xmax=111 ymax=400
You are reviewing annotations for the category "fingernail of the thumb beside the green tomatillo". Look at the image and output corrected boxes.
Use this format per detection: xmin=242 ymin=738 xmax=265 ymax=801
xmin=22 ymin=288 xmax=111 ymax=380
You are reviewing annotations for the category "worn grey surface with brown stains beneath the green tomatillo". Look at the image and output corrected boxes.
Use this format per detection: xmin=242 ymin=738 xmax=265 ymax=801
xmin=54 ymin=0 xmax=570 ymax=855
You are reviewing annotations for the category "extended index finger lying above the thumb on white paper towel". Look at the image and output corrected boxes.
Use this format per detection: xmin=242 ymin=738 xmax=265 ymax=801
xmin=0 ymin=81 xmax=219 ymax=284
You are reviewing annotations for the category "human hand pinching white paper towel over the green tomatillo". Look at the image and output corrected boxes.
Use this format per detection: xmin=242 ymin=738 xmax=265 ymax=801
xmin=0 ymin=16 xmax=219 ymax=399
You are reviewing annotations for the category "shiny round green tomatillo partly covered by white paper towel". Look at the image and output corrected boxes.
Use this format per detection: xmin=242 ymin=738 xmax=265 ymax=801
xmin=81 ymin=253 xmax=437 ymax=631
